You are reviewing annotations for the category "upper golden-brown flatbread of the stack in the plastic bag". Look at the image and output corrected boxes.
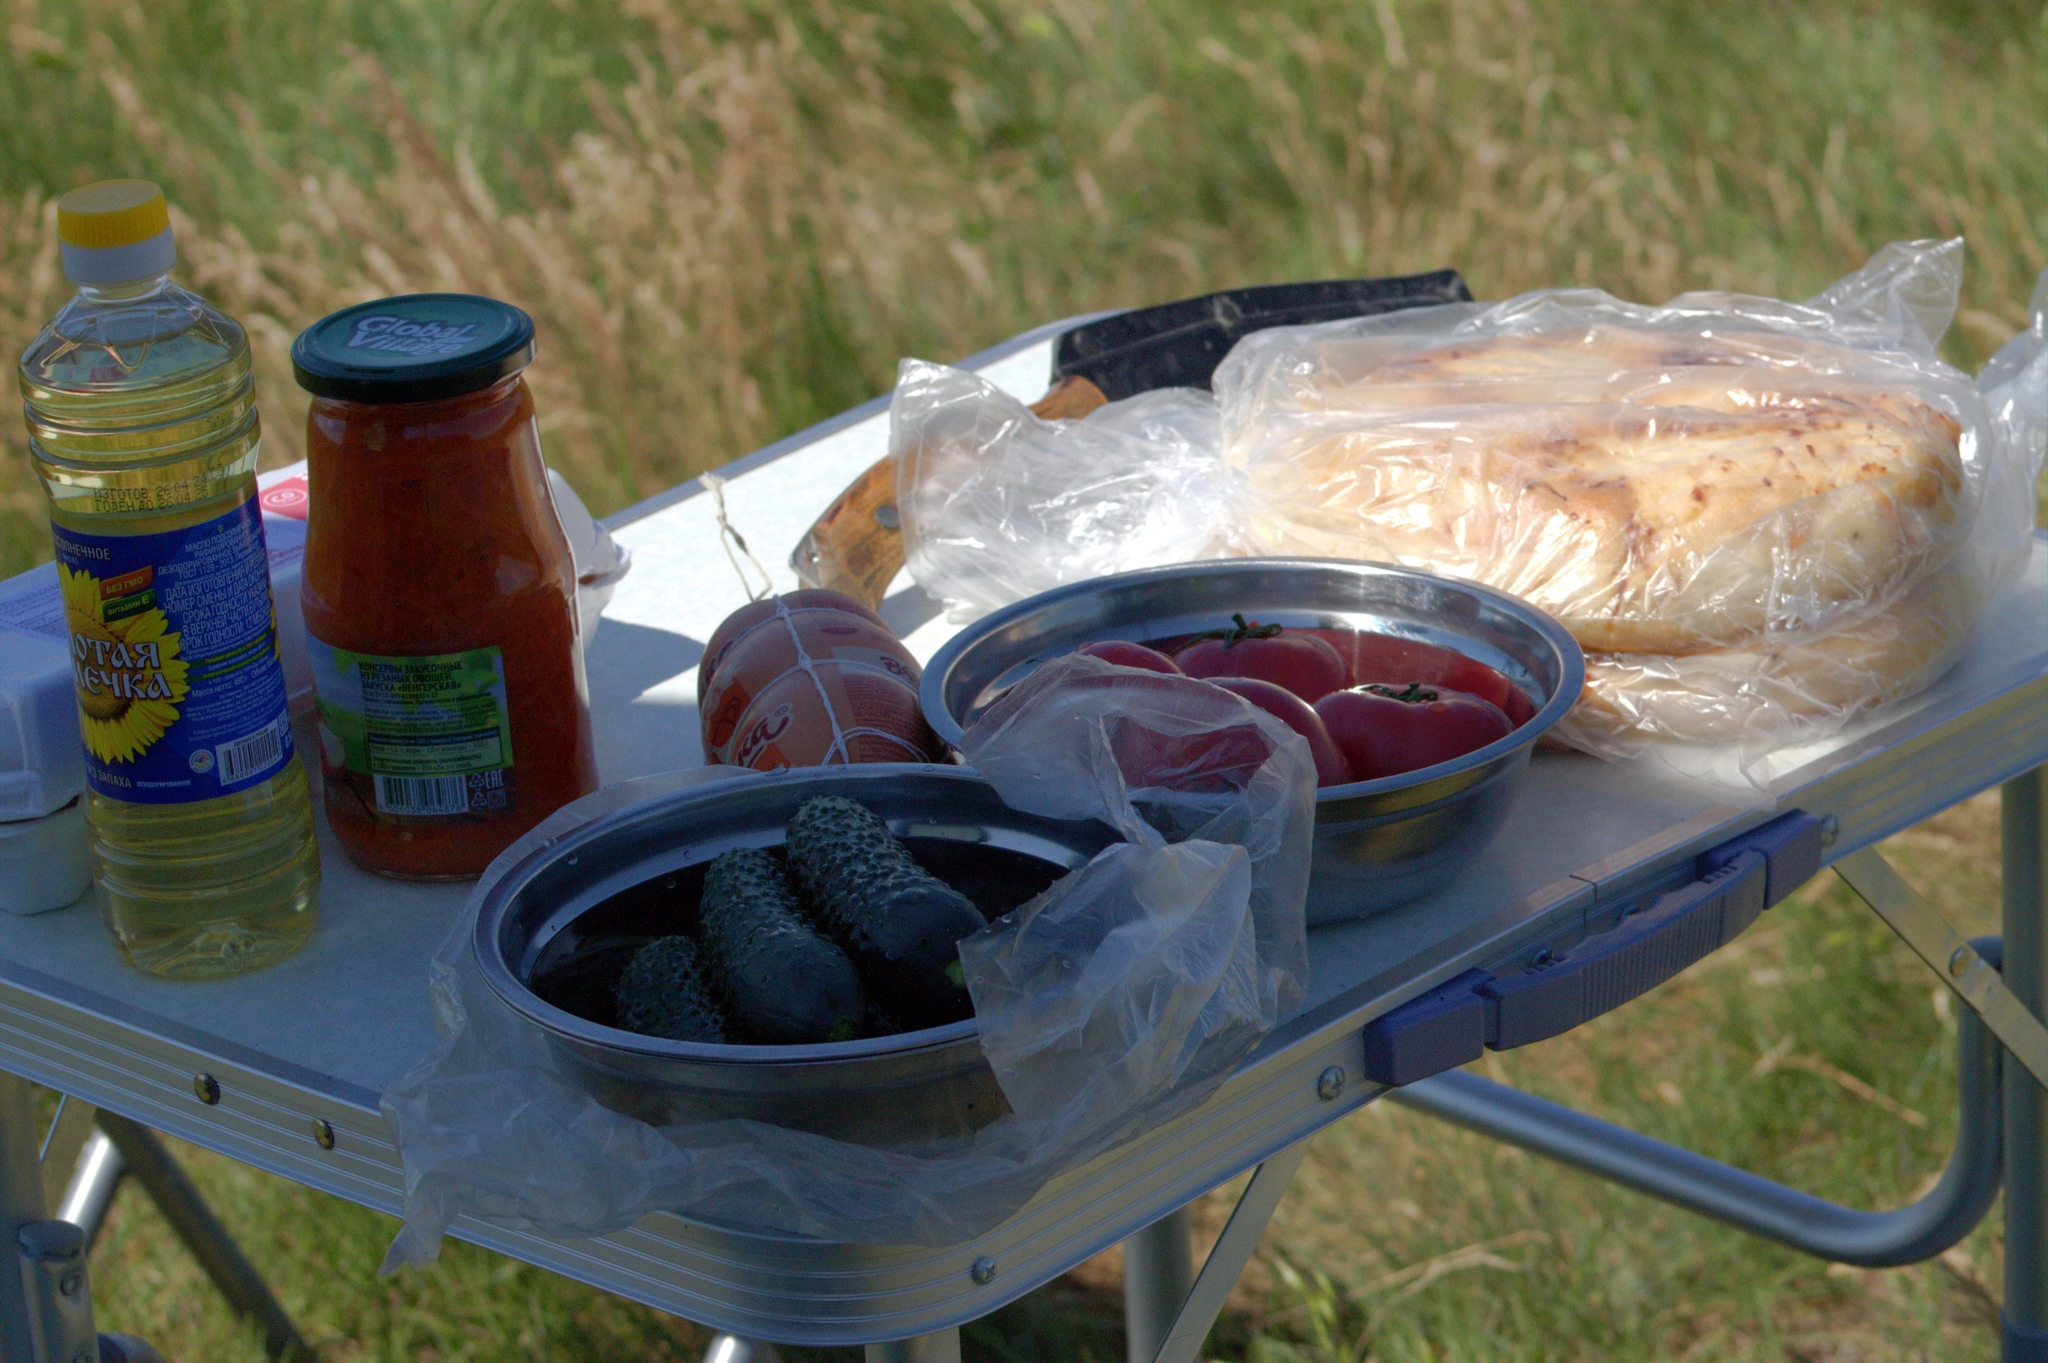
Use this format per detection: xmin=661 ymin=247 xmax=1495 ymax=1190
xmin=1225 ymin=325 xmax=1964 ymax=655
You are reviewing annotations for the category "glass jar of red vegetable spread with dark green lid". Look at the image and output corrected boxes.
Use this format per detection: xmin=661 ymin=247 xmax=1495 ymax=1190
xmin=291 ymin=293 xmax=598 ymax=880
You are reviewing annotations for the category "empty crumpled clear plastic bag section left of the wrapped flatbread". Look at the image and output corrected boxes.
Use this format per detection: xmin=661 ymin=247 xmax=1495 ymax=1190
xmin=889 ymin=360 xmax=1241 ymax=624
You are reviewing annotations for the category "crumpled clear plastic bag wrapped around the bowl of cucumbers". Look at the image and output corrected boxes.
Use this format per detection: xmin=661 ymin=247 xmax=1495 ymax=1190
xmin=383 ymin=657 xmax=1315 ymax=1269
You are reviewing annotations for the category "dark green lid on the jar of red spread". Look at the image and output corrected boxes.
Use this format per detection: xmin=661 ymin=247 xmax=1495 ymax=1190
xmin=291 ymin=293 xmax=532 ymax=403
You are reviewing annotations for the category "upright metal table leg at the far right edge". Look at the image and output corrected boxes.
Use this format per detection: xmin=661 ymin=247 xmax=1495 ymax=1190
xmin=1999 ymin=767 xmax=2048 ymax=1363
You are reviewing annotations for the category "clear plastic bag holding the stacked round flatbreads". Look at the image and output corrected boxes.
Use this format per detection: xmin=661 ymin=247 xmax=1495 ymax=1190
xmin=1217 ymin=241 xmax=2048 ymax=780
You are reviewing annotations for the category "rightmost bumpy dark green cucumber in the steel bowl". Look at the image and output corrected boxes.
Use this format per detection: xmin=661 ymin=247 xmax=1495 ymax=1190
xmin=788 ymin=796 xmax=987 ymax=1027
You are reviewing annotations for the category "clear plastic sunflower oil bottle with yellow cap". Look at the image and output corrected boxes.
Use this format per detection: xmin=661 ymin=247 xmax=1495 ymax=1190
xmin=20 ymin=180 xmax=319 ymax=978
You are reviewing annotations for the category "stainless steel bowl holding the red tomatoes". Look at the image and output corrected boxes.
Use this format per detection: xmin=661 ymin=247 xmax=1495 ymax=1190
xmin=918 ymin=559 xmax=1585 ymax=925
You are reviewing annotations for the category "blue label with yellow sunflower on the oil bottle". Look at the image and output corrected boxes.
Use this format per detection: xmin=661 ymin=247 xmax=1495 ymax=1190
xmin=51 ymin=495 xmax=291 ymax=804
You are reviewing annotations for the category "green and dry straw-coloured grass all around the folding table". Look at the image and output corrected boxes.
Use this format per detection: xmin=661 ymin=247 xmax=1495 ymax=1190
xmin=0 ymin=0 xmax=2048 ymax=1363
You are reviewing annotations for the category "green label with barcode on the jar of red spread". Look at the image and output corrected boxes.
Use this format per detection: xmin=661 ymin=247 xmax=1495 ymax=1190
xmin=305 ymin=639 xmax=512 ymax=817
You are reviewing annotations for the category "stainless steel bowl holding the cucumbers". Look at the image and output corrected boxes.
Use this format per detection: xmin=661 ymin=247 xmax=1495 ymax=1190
xmin=473 ymin=763 xmax=1118 ymax=1144
